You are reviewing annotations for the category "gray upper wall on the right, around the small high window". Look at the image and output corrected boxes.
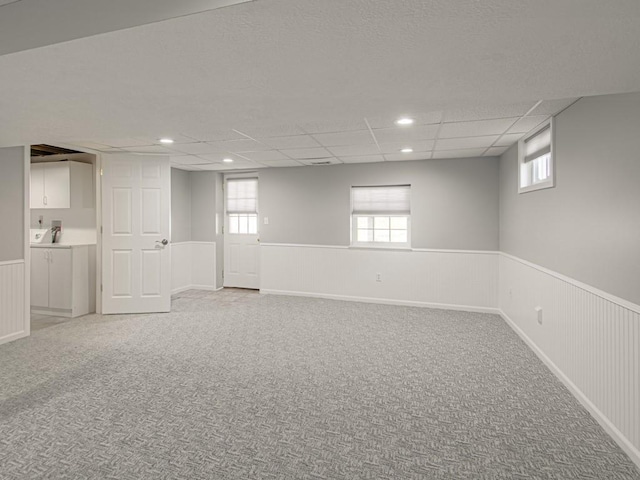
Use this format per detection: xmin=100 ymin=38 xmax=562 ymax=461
xmin=500 ymin=93 xmax=640 ymax=304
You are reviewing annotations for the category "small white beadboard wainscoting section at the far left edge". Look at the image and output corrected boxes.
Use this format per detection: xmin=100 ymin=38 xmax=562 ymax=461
xmin=0 ymin=260 xmax=29 ymax=344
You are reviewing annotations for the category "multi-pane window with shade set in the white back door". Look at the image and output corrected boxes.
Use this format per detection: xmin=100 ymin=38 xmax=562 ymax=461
xmin=227 ymin=178 xmax=258 ymax=235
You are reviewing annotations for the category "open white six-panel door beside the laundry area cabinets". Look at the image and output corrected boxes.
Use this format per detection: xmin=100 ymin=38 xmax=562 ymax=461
xmin=102 ymin=155 xmax=171 ymax=313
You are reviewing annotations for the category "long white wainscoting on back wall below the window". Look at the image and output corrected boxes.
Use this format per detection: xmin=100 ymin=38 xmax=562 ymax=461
xmin=260 ymin=244 xmax=498 ymax=313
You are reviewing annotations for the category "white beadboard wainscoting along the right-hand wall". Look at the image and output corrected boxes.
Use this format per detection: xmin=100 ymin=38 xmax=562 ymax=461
xmin=499 ymin=253 xmax=640 ymax=467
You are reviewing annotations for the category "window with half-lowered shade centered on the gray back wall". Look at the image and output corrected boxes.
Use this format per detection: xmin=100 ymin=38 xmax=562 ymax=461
xmin=351 ymin=185 xmax=411 ymax=247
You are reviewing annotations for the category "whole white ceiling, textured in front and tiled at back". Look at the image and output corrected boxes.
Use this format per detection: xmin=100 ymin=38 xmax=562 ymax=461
xmin=0 ymin=0 xmax=640 ymax=170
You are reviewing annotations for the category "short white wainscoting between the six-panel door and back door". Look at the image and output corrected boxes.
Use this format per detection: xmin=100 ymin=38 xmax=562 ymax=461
xmin=171 ymin=242 xmax=216 ymax=293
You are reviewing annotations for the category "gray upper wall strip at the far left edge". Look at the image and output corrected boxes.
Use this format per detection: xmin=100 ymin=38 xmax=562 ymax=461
xmin=0 ymin=147 xmax=25 ymax=262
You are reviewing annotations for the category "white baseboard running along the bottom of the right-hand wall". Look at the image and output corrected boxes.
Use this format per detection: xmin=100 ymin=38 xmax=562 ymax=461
xmin=498 ymin=309 xmax=640 ymax=468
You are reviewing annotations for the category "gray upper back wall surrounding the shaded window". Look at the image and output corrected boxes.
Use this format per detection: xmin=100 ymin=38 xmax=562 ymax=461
xmin=259 ymin=157 xmax=498 ymax=250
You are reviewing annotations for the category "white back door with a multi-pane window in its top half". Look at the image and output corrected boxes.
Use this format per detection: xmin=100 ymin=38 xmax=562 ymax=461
xmin=224 ymin=178 xmax=260 ymax=289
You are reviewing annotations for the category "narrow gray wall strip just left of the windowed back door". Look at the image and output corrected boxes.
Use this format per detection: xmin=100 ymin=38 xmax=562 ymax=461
xmin=190 ymin=172 xmax=217 ymax=242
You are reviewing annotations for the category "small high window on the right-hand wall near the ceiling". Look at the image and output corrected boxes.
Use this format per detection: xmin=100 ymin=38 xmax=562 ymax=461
xmin=518 ymin=120 xmax=555 ymax=193
